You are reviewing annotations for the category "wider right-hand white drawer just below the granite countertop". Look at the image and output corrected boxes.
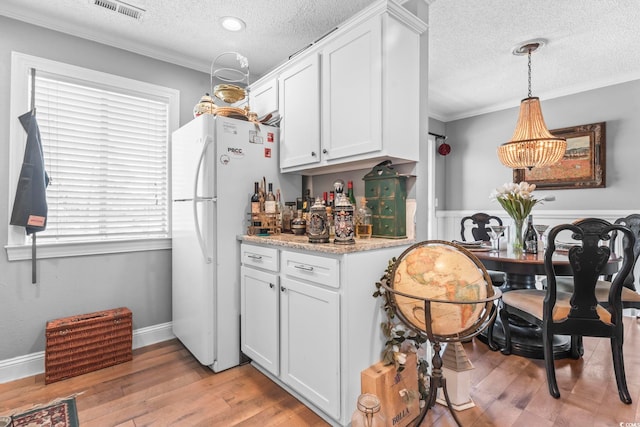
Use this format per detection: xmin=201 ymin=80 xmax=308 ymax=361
xmin=281 ymin=251 xmax=340 ymax=288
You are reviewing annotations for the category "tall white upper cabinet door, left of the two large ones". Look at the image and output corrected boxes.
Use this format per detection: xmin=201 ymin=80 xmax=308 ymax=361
xmin=278 ymin=54 xmax=320 ymax=169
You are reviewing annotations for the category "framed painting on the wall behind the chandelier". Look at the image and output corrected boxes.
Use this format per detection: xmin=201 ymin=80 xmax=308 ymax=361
xmin=513 ymin=122 xmax=606 ymax=190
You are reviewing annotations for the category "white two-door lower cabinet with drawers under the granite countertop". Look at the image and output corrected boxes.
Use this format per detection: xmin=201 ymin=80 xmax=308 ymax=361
xmin=241 ymin=243 xmax=407 ymax=426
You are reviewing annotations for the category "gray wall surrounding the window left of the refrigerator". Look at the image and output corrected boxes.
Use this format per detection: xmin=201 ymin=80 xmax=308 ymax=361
xmin=0 ymin=17 xmax=209 ymax=360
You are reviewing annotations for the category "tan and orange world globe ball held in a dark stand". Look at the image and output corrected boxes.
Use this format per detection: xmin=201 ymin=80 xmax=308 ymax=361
xmin=391 ymin=241 xmax=494 ymax=337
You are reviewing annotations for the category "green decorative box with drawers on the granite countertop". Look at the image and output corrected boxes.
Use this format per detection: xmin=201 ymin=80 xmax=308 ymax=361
xmin=362 ymin=160 xmax=408 ymax=239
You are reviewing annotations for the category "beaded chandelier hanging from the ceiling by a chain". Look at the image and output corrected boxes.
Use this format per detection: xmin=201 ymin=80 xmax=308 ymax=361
xmin=498 ymin=41 xmax=567 ymax=170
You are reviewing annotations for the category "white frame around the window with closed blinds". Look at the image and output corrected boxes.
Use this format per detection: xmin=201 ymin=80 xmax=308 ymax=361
xmin=5 ymin=51 xmax=180 ymax=261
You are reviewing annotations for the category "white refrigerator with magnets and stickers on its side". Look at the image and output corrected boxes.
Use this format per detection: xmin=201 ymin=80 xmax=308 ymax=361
xmin=171 ymin=114 xmax=302 ymax=372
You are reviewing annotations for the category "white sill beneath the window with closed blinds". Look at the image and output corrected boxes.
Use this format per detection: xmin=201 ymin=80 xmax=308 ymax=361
xmin=5 ymin=238 xmax=171 ymax=261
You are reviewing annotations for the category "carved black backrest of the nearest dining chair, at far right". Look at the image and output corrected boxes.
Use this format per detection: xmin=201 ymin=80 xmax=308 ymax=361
xmin=544 ymin=218 xmax=635 ymax=330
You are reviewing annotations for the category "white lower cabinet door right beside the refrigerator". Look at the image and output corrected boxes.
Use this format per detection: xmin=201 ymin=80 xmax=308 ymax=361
xmin=240 ymin=266 xmax=280 ymax=375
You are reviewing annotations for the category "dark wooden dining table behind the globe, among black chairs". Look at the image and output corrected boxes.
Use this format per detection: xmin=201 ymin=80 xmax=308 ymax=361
xmin=472 ymin=248 xmax=620 ymax=359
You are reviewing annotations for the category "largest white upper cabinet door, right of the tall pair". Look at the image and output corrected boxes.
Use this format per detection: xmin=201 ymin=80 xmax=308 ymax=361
xmin=322 ymin=16 xmax=382 ymax=163
